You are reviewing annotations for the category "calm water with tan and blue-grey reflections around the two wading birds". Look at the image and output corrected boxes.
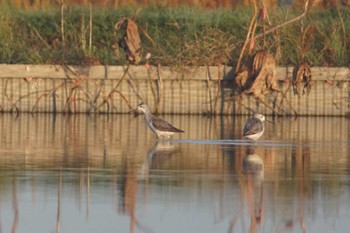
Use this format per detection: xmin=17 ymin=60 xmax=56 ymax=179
xmin=0 ymin=114 xmax=350 ymax=233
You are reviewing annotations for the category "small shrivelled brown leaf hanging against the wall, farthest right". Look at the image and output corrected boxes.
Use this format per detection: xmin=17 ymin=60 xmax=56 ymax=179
xmin=292 ymin=62 xmax=312 ymax=96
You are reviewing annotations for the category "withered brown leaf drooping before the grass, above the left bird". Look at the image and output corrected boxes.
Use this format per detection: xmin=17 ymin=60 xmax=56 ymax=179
xmin=114 ymin=18 xmax=141 ymax=64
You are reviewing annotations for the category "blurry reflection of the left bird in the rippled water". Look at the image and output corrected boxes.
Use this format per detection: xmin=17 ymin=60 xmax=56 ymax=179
xmin=138 ymin=140 xmax=180 ymax=180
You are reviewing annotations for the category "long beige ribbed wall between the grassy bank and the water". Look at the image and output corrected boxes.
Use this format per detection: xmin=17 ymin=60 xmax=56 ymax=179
xmin=0 ymin=64 xmax=350 ymax=116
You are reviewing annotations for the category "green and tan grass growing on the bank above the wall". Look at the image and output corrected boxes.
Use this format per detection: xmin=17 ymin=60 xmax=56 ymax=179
xmin=0 ymin=6 xmax=350 ymax=66
